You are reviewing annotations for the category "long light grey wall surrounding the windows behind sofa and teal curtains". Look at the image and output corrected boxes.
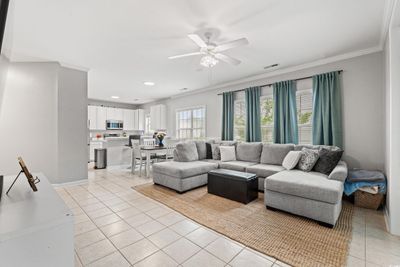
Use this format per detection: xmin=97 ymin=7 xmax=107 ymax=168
xmin=142 ymin=52 xmax=384 ymax=170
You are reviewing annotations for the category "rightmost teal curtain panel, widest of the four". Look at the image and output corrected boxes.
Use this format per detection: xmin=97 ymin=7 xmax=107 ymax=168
xmin=312 ymin=71 xmax=343 ymax=148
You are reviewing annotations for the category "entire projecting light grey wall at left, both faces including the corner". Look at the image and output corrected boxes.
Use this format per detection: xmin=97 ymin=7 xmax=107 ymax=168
xmin=0 ymin=62 xmax=88 ymax=183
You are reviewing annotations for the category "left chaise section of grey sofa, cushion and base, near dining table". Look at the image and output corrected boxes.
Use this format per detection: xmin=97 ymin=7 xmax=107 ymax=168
xmin=153 ymin=161 xmax=218 ymax=193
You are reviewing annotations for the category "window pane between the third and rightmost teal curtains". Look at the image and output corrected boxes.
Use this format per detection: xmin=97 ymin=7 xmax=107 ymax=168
xmin=296 ymin=90 xmax=312 ymax=144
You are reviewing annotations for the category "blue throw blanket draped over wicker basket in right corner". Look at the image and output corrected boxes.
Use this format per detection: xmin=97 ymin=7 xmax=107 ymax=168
xmin=344 ymin=170 xmax=386 ymax=196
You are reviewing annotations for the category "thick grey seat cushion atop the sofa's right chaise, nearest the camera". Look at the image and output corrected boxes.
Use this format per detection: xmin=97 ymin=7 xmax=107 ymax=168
xmin=264 ymin=170 xmax=343 ymax=204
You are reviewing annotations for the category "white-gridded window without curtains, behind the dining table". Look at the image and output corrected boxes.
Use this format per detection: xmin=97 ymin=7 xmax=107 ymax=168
xmin=176 ymin=107 xmax=206 ymax=139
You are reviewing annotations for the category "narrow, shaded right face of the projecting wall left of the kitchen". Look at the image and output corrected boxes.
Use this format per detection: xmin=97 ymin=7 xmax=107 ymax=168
xmin=57 ymin=67 xmax=88 ymax=182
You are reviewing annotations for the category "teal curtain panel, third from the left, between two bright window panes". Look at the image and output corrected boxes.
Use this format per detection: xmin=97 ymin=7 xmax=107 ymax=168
xmin=273 ymin=81 xmax=298 ymax=144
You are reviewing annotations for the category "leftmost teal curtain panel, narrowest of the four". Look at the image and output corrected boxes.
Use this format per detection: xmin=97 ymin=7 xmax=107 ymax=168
xmin=222 ymin=92 xmax=234 ymax=140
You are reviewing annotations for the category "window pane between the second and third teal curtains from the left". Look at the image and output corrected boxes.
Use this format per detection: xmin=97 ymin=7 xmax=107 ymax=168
xmin=260 ymin=95 xmax=274 ymax=143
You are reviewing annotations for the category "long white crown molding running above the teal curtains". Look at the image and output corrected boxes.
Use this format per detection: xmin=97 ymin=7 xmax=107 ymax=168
xmin=170 ymin=45 xmax=383 ymax=99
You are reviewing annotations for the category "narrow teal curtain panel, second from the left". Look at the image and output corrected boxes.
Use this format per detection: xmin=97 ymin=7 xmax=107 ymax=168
xmin=245 ymin=86 xmax=261 ymax=142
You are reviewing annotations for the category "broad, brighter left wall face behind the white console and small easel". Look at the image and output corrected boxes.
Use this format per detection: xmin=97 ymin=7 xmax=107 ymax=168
xmin=0 ymin=63 xmax=59 ymax=180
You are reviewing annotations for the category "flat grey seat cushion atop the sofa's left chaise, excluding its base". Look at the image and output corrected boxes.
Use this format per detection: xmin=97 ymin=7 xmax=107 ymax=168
xmin=153 ymin=161 xmax=218 ymax=179
